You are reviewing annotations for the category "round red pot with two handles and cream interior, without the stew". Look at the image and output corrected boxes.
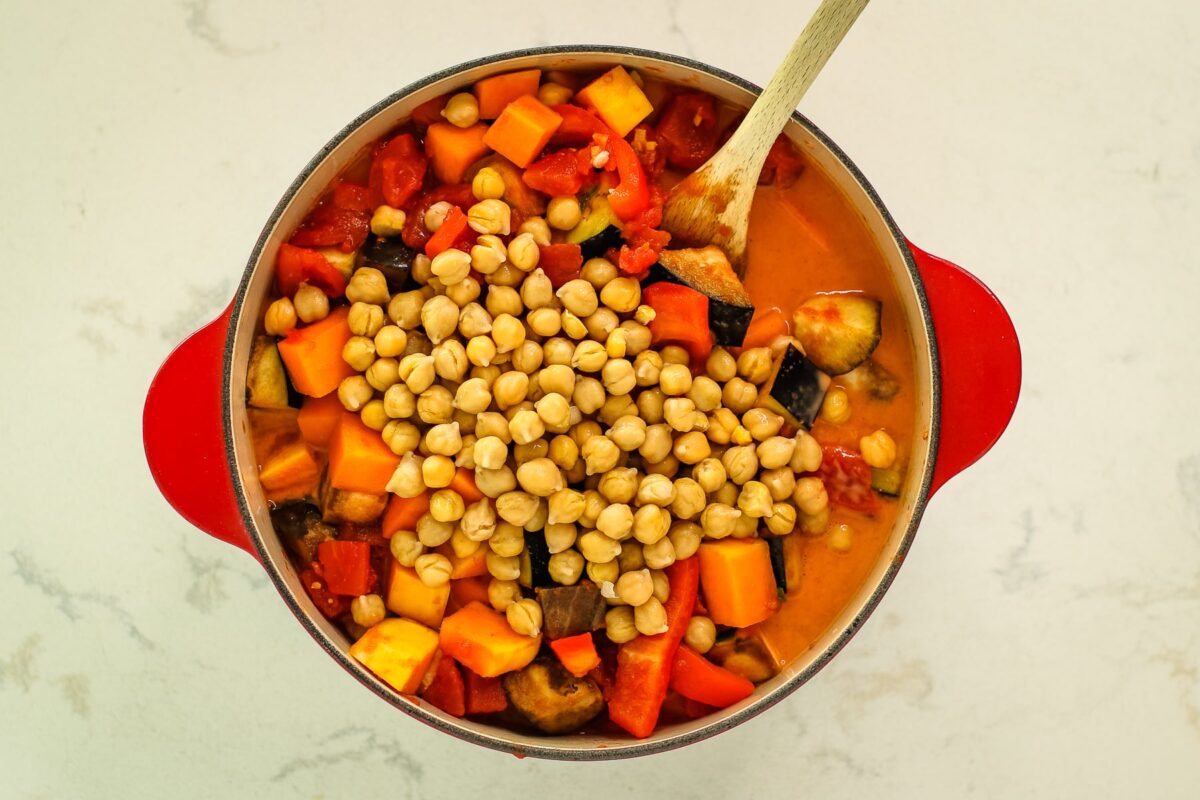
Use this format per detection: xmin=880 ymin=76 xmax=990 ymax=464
xmin=143 ymin=46 xmax=1021 ymax=759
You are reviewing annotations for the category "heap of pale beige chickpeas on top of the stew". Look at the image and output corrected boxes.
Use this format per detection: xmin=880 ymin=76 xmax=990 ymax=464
xmin=265 ymin=168 xmax=878 ymax=652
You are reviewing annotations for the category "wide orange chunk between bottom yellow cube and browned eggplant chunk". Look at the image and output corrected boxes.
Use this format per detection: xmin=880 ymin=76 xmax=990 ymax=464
xmin=442 ymin=602 xmax=541 ymax=678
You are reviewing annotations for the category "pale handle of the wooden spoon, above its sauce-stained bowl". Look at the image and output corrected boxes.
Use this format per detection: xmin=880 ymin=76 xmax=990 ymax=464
xmin=722 ymin=0 xmax=870 ymax=178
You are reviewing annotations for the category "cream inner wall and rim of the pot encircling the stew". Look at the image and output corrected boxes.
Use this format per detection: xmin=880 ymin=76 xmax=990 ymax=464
xmin=228 ymin=50 xmax=934 ymax=759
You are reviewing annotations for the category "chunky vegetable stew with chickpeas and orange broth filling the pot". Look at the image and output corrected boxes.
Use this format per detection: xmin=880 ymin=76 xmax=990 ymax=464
xmin=246 ymin=66 xmax=914 ymax=738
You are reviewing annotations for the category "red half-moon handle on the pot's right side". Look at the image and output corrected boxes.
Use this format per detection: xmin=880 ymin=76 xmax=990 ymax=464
xmin=908 ymin=242 xmax=1021 ymax=497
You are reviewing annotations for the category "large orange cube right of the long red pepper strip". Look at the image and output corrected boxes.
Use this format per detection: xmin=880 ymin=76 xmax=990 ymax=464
xmin=700 ymin=539 xmax=779 ymax=627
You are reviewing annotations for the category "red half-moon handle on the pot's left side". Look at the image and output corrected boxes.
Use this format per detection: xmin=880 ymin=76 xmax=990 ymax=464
xmin=142 ymin=303 xmax=258 ymax=559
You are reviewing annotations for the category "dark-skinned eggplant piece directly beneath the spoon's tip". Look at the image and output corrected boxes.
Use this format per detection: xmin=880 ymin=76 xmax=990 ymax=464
xmin=648 ymin=245 xmax=754 ymax=347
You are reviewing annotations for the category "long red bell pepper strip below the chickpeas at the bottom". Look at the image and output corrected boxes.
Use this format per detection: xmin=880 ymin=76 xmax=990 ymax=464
xmin=608 ymin=557 xmax=700 ymax=739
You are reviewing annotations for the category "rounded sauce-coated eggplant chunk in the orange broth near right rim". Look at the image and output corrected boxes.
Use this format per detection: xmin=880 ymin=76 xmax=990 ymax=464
xmin=792 ymin=294 xmax=882 ymax=375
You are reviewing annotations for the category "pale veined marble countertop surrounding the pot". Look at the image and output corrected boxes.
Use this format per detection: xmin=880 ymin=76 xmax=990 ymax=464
xmin=0 ymin=0 xmax=1200 ymax=800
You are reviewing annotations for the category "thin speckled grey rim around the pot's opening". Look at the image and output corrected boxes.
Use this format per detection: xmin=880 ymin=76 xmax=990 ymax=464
xmin=220 ymin=44 xmax=941 ymax=760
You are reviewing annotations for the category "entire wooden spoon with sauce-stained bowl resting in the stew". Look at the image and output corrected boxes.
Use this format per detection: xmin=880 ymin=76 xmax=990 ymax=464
xmin=662 ymin=0 xmax=869 ymax=276
